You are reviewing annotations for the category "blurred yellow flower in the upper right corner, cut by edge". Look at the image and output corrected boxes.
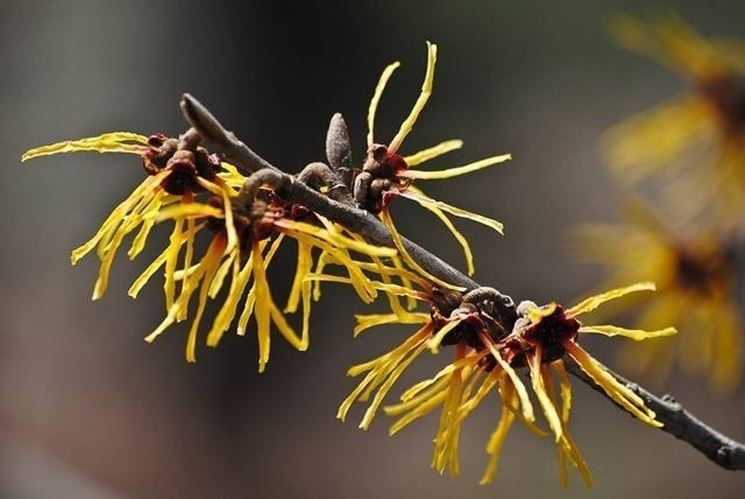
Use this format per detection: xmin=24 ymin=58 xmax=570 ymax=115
xmin=605 ymin=16 xmax=745 ymax=220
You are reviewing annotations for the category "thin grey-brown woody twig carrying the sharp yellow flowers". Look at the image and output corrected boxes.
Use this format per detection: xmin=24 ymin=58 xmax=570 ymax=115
xmin=181 ymin=94 xmax=745 ymax=470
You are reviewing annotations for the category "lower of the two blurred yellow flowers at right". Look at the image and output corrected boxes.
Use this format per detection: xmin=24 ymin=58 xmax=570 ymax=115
xmin=575 ymin=203 xmax=743 ymax=391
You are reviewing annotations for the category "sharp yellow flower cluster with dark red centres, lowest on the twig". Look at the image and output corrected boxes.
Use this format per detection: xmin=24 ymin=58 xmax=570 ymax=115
xmin=338 ymin=283 xmax=675 ymax=486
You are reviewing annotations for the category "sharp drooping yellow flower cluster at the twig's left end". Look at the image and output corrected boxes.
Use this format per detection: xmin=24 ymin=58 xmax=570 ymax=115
xmin=23 ymin=132 xmax=398 ymax=371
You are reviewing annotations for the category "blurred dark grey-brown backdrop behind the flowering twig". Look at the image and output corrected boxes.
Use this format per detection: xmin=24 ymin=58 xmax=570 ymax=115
xmin=0 ymin=0 xmax=745 ymax=498
